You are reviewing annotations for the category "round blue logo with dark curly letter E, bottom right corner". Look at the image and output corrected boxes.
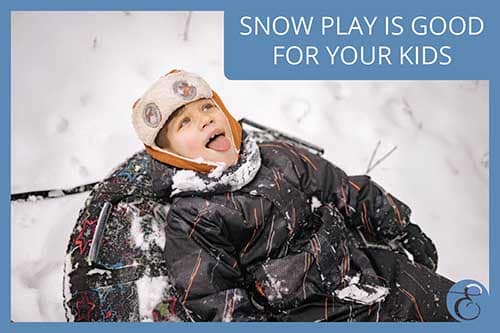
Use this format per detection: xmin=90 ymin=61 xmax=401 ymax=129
xmin=446 ymin=280 xmax=488 ymax=321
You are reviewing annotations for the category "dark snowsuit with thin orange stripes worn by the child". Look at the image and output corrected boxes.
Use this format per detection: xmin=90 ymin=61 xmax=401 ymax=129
xmin=158 ymin=134 xmax=452 ymax=321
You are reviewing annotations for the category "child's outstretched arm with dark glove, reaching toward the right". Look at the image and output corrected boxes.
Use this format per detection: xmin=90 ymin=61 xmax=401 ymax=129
xmin=262 ymin=143 xmax=437 ymax=269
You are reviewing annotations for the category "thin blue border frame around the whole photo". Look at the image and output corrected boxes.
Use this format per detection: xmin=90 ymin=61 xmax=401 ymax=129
xmin=0 ymin=0 xmax=500 ymax=332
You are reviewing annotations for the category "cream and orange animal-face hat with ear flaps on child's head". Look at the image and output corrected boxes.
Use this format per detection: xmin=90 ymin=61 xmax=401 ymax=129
xmin=132 ymin=69 xmax=242 ymax=173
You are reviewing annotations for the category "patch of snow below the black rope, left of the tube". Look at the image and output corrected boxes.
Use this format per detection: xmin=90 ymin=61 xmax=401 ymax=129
xmin=11 ymin=194 xmax=86 ymax=321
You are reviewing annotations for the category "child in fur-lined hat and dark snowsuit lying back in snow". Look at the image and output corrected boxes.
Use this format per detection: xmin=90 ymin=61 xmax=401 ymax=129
xmin=128 ymin=70 xmax=453 ymax=321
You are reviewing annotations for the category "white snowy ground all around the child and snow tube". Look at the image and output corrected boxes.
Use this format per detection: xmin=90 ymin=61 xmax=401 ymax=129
xmin=11 ymin=12 xmax=489 ymax=321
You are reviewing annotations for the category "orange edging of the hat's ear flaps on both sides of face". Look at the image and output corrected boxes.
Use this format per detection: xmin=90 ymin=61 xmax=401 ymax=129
xmin=144 ymin=90 xmax=242 ymax=173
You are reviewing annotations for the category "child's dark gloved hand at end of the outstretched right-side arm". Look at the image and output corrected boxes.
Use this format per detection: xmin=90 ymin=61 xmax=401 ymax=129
xmin=400 ymin=223 xmax=438 ymax=271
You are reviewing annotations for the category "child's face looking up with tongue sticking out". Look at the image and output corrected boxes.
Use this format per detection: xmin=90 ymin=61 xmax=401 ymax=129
xmin=158 ymin=98 xmax=238 ymax=166
